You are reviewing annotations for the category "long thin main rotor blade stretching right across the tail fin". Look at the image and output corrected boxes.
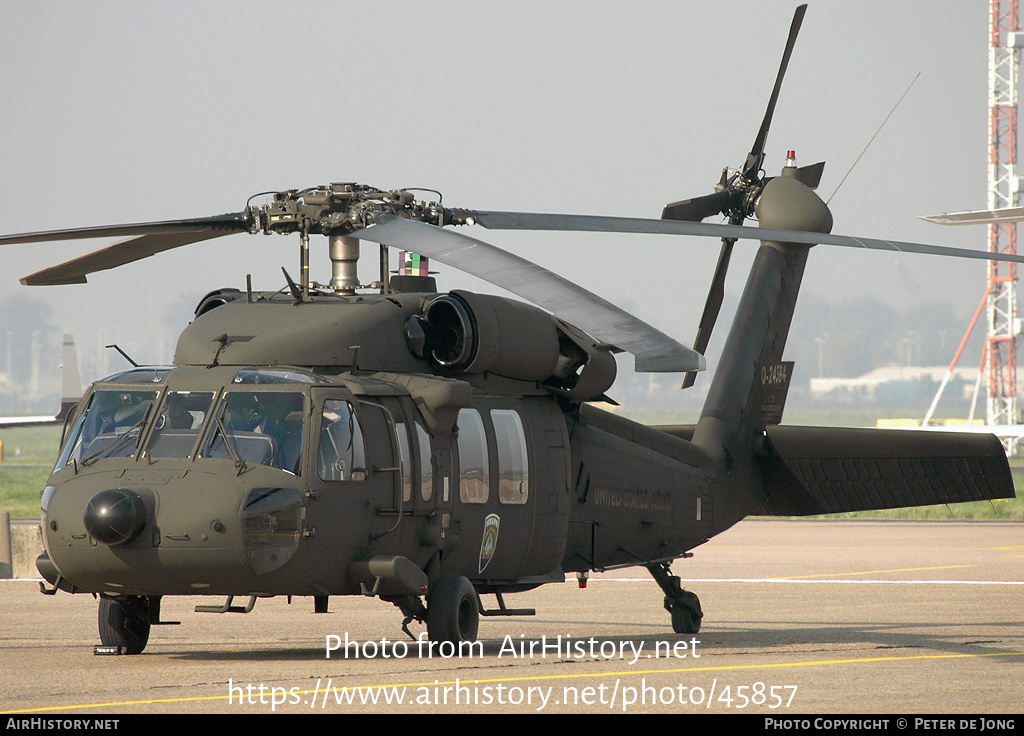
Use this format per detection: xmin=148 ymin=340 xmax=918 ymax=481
xmin=467 ymin=212 xmax=1024 ymax=263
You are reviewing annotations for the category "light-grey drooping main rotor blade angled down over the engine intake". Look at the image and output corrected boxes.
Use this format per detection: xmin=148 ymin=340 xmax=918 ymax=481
xmin=351 ymin=218 xmax=706 ymax=373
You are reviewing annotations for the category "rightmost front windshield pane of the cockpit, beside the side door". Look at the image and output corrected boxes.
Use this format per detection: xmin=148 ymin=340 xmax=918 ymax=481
xmin=202 ymin=391 xmax=305 ymax=474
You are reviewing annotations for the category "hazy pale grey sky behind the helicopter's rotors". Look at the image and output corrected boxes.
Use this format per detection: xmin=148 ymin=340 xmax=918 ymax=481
xmin=0 ymin=0 xmax=1003 ymax=391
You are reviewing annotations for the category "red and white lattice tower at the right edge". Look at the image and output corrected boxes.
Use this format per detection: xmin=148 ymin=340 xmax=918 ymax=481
xmin=984 ymin=0 xmax=1024 ymax=449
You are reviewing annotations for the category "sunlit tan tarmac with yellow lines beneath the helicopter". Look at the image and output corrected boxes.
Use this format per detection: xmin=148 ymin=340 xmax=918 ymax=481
xmin=0 ymin=520 xmax=1024 ymax=722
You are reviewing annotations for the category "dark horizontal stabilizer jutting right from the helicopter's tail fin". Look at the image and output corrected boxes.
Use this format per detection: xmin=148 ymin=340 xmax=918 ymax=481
xmin=757 ymin=426 xmax=1014 ymax=516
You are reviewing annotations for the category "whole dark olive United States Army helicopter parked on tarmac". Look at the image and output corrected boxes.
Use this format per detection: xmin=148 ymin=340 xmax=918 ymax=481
xmin=0 ymin=6 xmax=1024 ymax=654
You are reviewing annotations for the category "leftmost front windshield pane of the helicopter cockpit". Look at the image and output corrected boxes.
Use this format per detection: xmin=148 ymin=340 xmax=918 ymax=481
xmin=57 ymin=389 xmax=158 ymax=467
